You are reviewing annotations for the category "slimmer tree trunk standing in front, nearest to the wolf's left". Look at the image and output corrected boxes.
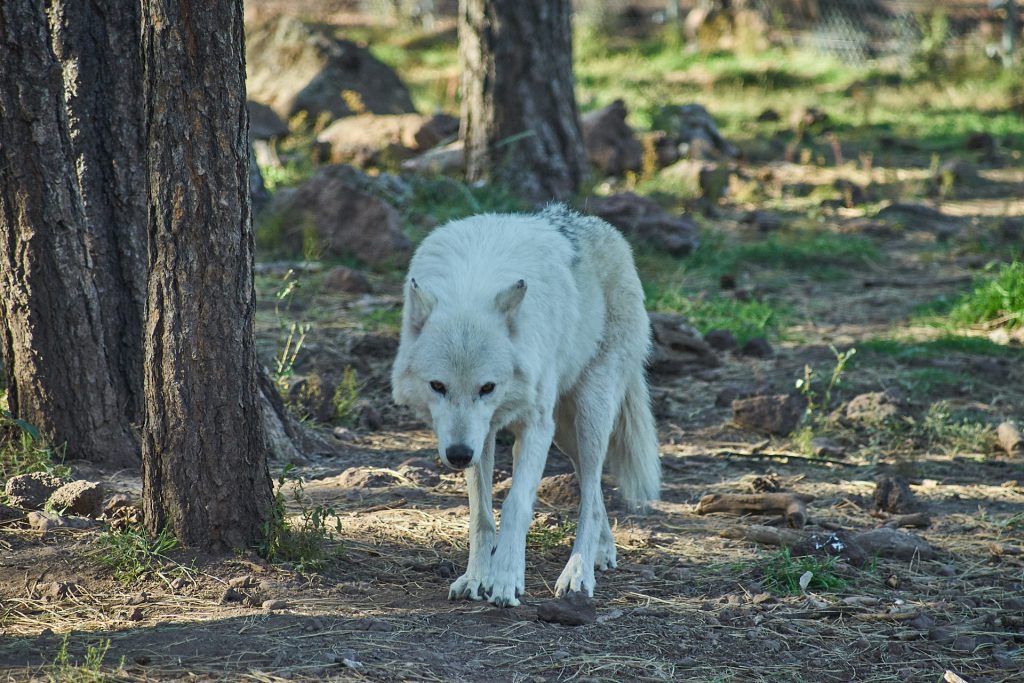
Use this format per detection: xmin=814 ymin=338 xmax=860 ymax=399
xmin=142 ymin=0 xmax=271 ymax=550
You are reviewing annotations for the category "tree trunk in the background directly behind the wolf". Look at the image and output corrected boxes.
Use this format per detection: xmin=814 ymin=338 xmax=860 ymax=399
xmin=459 ymin=0 xmax=587 ymax=202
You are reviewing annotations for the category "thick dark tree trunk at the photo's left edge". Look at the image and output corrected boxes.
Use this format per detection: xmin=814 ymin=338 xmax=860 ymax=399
xmin=0 ymin=0 xmax=145 ymax=466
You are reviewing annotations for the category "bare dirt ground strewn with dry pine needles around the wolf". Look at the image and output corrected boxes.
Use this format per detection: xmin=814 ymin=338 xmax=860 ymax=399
xmin=0 ymin=188 xmax=1024 ymax=681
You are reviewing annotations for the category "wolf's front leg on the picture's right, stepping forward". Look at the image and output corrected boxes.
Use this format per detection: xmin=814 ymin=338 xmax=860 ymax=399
xmin=484 ymin=411 xmax=555 ymax=607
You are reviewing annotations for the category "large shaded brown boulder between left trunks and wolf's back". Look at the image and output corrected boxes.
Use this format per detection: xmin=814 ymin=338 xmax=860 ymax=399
xmin=266 ymin=165 xmax=412 ymax=265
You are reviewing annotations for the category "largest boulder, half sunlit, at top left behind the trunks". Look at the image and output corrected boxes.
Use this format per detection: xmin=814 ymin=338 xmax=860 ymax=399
xmin=246 ymin=15 xmax=416 ymax=125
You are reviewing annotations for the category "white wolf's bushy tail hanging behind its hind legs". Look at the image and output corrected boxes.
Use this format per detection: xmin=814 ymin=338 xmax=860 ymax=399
xmin=607 ymin=368 xmax=662 ymax=510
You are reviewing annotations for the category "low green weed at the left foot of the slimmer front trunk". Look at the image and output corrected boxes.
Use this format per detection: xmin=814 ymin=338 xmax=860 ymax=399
xmin=96 ymin=524 xmax=191 ymax=585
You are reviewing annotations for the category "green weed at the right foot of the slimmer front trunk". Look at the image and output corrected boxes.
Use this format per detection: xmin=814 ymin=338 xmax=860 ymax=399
xmin=258 ymin=465 xmax=344 ymax=572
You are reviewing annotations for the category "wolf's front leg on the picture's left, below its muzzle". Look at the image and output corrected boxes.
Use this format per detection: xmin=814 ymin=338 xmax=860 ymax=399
xmin=449 ymin=432 xmax=495 ymax=600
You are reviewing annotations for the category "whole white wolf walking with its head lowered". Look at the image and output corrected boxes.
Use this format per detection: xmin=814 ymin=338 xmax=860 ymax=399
xmin=391 ymin=205 xmax=660 ymax=606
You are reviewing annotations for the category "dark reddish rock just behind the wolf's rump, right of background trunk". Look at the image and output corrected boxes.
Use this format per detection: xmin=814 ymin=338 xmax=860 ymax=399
xmin=585 ymin=193 xmax=698 ymax=256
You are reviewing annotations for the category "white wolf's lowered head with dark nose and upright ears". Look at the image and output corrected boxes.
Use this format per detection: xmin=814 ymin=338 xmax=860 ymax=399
xmin=391 ymin=280 xmax=526 ymax=469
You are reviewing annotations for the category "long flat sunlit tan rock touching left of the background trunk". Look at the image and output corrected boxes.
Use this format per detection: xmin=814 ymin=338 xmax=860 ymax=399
xmin=316 ymin=114 xmax=459 ymax=166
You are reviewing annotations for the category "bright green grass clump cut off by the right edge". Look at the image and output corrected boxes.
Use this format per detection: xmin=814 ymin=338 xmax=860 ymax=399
xmin=949 ymin=261 xmax=1024 ymax=330
